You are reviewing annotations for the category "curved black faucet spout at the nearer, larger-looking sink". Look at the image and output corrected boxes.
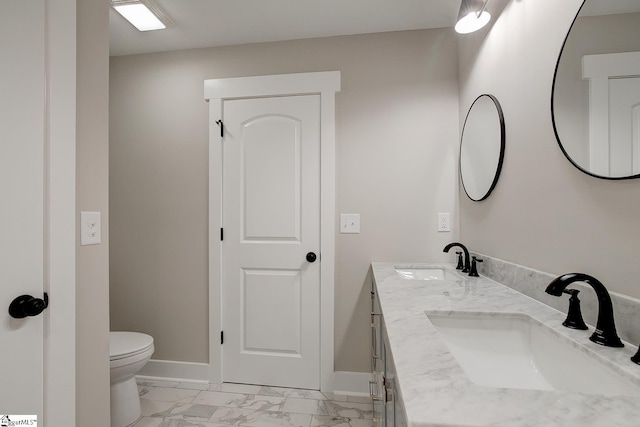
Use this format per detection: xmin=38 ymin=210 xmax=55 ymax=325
xmin=545 ymin=273 xmax=624 ymax=347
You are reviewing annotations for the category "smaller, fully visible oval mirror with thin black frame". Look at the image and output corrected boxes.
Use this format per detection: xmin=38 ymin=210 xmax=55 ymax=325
xmin=460 ymin=94 xmax=504 ymax=201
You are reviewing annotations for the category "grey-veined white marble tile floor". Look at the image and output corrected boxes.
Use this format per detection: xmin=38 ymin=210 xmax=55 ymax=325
xmin=133 ymin=379 xmax=373 ymax=427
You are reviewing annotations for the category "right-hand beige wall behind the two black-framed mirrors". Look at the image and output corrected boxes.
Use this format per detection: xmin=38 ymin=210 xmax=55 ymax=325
xmin=459 ymin=0 xmax=640 ymax=298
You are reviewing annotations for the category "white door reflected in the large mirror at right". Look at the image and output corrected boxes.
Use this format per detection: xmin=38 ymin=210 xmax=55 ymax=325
xmin=609 ymin=77 xmax=640 ymax=176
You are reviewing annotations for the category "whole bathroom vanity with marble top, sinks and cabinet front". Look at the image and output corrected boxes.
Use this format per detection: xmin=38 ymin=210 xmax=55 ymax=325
xmin=370 ymin=263 xmax=640 ymax=427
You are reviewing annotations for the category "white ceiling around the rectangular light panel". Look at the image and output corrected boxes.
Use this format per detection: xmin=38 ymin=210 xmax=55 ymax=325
xmin=109 ymin=0 xmax=460 ymax=56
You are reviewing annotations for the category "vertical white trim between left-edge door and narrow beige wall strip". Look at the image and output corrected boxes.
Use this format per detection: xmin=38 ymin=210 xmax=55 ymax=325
xmin=44 ymin=0 xmax=76 ymax=427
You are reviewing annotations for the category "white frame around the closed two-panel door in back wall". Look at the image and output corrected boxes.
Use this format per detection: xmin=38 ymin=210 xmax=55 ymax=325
xmin=204 ymin=71 xmax=340 ymax=391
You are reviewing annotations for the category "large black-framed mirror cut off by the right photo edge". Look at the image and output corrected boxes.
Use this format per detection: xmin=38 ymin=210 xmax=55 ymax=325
xmin=551 ymin=0 xmax=640 ymax=179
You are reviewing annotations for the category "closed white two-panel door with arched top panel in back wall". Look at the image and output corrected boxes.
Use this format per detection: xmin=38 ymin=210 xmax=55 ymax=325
xmin=222 ymin=95 xmax=320 ymax=389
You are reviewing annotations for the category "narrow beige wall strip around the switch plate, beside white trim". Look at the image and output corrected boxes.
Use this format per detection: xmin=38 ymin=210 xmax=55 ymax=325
xmin=75 ymin=0 xmax=109 ymax=427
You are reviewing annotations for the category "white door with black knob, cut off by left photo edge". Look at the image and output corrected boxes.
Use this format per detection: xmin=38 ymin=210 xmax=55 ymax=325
xmin=0 ymin=0 xmax=46 ymax=420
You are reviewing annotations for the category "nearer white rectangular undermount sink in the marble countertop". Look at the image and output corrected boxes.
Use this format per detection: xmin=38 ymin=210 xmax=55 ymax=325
xmin=425 ymin=311 xmax=640 ymax=397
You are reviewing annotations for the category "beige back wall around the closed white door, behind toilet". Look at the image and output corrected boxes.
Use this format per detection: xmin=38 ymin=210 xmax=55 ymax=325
xmin=110 ymin=29 xmax=459 ymax=372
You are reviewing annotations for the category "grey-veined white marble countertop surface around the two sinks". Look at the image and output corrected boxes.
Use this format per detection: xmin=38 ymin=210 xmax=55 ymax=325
xmin=372 ymin=262 xmax=640 ymax=427
